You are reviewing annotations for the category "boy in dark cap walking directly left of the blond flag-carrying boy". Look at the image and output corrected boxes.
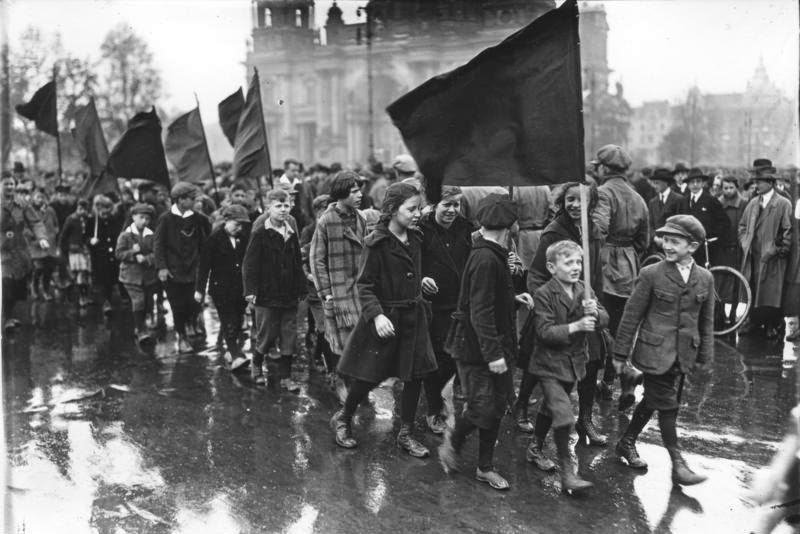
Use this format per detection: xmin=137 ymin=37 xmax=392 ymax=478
xmin=439 ymin=193 xmax=533 ymax=490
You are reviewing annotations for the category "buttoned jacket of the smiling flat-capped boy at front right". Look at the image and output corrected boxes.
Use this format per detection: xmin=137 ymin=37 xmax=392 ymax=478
xmin=614 ymin=260 xmax=714 ymax=375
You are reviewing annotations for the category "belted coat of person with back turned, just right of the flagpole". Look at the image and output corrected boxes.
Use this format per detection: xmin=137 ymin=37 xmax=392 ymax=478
xmin=592 ymin=175 xmax=650 ymax=298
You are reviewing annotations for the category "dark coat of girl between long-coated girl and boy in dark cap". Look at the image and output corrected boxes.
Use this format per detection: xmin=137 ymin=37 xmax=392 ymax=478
xmin=419 ymin=212 xmax=474 ymax=313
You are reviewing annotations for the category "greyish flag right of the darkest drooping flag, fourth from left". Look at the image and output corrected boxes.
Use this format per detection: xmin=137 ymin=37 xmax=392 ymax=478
xmin=164 ymin=108 xmax=214 ymax=183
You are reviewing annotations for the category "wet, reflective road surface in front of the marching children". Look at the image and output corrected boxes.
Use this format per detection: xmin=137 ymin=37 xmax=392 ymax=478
xmin=3 ymin=303 xmax=797 ymax=534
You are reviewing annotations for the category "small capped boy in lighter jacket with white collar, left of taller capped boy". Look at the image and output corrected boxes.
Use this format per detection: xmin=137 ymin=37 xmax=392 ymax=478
xmin=115 ymin=203 xmax=157 ymax=346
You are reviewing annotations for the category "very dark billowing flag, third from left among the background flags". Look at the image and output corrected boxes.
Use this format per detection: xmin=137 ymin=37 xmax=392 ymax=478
xmin=108 ymin=107 xmax=170 ymax=189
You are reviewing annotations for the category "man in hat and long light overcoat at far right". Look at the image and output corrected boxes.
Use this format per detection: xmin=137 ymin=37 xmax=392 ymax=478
xmin=739 ymin=158 xmax=792 ymax=337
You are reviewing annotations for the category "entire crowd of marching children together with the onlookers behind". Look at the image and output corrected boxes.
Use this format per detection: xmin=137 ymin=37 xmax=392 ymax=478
xmin=0 ymin=145 xmax=798 ymax=491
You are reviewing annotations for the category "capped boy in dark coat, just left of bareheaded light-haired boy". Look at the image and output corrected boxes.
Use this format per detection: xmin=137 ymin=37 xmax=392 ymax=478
xmin=194 ymin=204 xmax=250 ymax=371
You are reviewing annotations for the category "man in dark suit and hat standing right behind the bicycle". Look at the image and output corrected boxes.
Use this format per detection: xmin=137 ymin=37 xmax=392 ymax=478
xmin=686 ymin=167 xmax=728 ymax=267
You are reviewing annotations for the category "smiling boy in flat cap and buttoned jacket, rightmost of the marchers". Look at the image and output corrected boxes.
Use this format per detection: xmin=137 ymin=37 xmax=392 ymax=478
xmin=614 ymin=215 xmax=714 ymax=486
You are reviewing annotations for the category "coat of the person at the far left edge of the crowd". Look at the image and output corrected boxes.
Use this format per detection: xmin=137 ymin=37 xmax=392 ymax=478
xmin=0 ymin=200 xmax=46 ymax=280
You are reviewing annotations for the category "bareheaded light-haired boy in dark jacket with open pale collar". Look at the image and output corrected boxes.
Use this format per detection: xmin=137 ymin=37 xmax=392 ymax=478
xmin=242 ymin=189 xmax=306 ymax=392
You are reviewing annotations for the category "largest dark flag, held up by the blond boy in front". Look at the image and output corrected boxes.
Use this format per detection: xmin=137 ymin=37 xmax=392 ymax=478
xmin=387 ymin=0 xmax=584 ymax=201
